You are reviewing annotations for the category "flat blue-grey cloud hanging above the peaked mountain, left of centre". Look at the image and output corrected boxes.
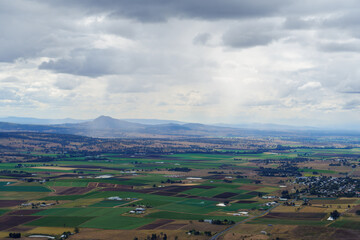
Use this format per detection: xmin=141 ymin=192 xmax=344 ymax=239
xmin=39 ymin=48 xmax=183 ymax=77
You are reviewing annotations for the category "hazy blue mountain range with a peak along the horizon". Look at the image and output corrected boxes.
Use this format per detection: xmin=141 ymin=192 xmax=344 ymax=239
xmin=0 ymin=116 xmax=358 ymax=138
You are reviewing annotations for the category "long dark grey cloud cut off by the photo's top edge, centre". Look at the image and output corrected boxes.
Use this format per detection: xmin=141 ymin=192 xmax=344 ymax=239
xmin=49 ymin=0 xmax=293 ymax=22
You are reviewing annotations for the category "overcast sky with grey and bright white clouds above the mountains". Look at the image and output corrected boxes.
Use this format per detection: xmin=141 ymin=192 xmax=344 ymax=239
xmin=0 ymin=0 xmax=360 ymax=127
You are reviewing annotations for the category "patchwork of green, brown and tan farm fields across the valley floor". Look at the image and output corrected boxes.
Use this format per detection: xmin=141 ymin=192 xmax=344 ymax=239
xmin=0 ymin=138 xmax=360 ymax=239
